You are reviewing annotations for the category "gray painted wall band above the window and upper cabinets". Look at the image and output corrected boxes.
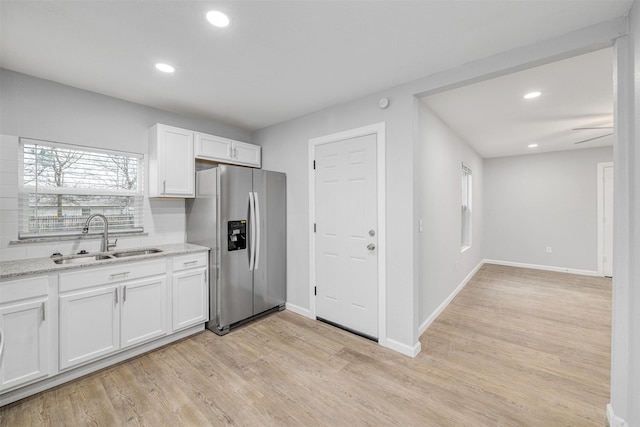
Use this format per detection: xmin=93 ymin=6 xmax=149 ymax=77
xmin=0 ymin=69 xmax=250 ymax=153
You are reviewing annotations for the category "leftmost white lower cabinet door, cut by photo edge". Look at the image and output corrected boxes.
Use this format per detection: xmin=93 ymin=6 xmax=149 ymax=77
xmin=0 ymin=298 xmax=49 ymax=390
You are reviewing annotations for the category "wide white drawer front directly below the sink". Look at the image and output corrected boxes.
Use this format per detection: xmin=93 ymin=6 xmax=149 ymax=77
xmin=60 ymin=258 xmax=167 ymax=292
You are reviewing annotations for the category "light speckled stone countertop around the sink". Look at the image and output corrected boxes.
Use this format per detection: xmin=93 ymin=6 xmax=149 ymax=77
xmin=0 ymin=243 xmax=209 ymax=279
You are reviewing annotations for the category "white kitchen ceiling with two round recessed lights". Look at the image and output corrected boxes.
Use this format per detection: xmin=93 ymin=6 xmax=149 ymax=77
xmin=0 ymin=0 xmax=632 ymax=137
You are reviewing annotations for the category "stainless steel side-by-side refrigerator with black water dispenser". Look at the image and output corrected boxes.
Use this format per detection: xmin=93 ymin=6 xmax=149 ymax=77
xmin=186 ymin=165 xmax=286 ymax=335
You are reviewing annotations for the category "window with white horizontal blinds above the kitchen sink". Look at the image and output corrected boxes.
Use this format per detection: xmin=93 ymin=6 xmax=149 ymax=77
xmin=18 ymin=138 xmax=144 ymax=239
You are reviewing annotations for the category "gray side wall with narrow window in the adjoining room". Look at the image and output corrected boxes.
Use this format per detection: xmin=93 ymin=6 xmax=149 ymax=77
xmin=414 ymin=102 xmax=485 ymax=324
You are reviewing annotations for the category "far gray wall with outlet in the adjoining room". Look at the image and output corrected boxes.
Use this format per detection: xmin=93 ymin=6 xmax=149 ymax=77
xmin=484 ymin=147 xmax=613 ymax=272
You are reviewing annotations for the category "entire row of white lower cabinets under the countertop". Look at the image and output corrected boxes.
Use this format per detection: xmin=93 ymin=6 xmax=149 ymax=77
xmin=0 ymin=252 xmax=209 ymax=406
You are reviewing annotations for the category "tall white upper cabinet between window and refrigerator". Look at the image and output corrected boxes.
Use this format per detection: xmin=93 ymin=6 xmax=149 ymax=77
xmin=149 ymin=124 xmax=195 ymax=197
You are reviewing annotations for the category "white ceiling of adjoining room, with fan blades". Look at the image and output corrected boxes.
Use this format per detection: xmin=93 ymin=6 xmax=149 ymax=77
xmin=423 ymin=49 xmax=613 ymax=158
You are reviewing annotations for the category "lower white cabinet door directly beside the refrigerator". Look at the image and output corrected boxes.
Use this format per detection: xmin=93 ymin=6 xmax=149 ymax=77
xmin=172 ymin=268 xmax=209 ymax=331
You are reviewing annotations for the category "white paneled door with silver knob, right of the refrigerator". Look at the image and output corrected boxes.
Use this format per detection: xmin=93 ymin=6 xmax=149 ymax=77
xmin=315 ymin=134 xmax=379 ymax=338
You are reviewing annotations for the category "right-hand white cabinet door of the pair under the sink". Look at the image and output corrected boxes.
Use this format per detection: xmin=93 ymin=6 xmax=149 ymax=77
xmin=120 ymin=276 xmax=167 ymax=348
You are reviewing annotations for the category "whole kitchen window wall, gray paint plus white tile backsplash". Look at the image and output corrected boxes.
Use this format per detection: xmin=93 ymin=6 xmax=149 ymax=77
xmin=0 ymin=69 xmax=250 ymax=260
